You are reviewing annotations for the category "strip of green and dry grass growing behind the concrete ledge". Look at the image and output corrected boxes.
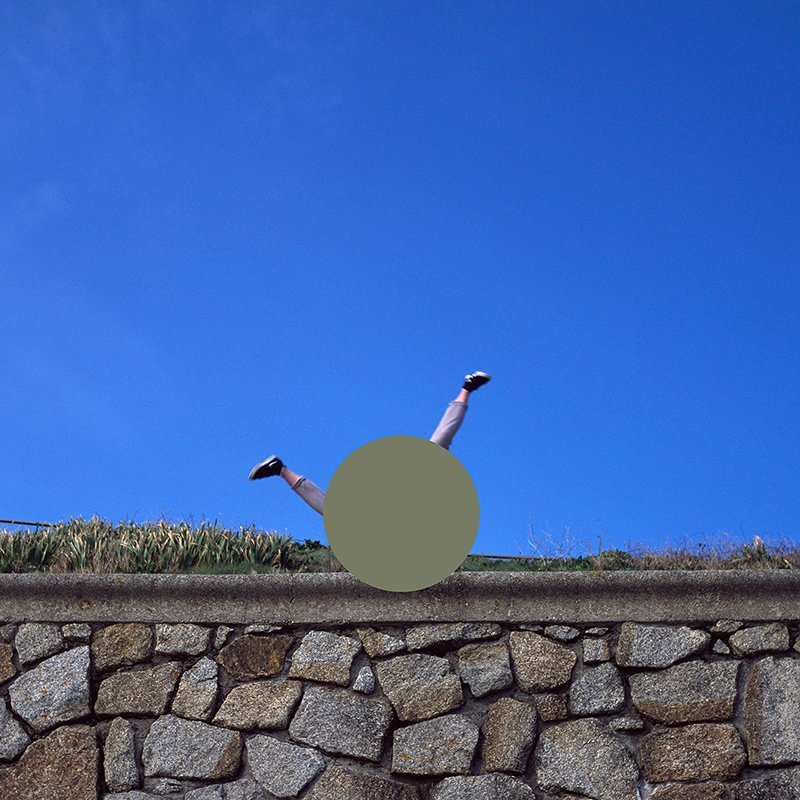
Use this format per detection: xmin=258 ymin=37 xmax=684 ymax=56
xmin=0 ymin=517 xmax=800 ymax=575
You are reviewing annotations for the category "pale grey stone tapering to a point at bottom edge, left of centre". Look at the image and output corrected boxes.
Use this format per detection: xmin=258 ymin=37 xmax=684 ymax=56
xmin=246 ymin=736 xmax=325 ymax=797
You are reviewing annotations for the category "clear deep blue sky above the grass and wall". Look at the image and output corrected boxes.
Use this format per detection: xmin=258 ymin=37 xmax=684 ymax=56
xmin=0 ymin=0 xmax=800 ymax=554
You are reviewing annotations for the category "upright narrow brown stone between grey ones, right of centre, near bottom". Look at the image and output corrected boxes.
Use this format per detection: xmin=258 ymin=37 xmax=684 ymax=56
xmin=482 ymin=697 xmax=536 ymax=774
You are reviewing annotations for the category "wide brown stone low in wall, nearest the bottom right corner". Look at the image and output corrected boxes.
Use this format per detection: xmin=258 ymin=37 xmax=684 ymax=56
xmin=639 ymin=722 xmax=746 ymax=783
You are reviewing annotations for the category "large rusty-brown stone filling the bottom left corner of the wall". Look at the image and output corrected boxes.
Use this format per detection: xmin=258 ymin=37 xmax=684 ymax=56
xmin=0 ymin=724 xmax=99 ymax=800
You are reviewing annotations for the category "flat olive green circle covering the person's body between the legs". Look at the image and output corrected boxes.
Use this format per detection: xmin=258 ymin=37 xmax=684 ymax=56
xmin=324 ymin=436 xmax=480 ymax=592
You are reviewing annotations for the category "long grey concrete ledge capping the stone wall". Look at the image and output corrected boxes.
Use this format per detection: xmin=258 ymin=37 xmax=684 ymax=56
xmin=0 ymin=570 xmax=800 ymax=625
